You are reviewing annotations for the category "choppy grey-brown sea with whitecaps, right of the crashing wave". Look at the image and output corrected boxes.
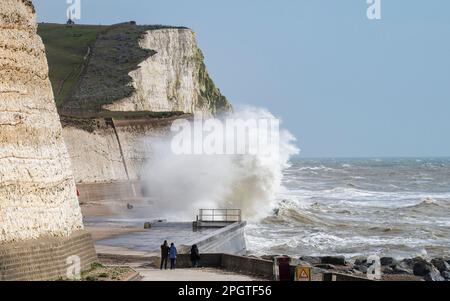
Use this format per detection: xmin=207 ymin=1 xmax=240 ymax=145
xmin=246 ymin=158 xmax=450 ymax=258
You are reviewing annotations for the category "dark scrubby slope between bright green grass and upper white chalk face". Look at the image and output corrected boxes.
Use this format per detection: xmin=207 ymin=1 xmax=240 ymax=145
xmin=65 ymin=23 xmax=156 ymax=110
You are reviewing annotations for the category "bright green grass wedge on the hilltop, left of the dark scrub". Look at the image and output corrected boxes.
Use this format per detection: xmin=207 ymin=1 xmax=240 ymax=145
xmin=38 ymin=23 xmax=108 ymax=106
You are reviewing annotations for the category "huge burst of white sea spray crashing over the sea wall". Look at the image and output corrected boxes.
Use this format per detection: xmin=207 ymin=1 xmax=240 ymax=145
xmin=141 ymin=107 xmax=299 ymax=220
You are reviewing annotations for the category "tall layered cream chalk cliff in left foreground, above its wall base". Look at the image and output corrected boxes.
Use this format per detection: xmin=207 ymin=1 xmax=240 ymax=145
xmin=0 ymin=0 xmax=83 ymax=242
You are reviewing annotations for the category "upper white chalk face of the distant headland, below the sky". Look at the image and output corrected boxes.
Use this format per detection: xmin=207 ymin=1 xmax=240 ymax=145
xmin=103 ymin=28 xmax=231 ymax=115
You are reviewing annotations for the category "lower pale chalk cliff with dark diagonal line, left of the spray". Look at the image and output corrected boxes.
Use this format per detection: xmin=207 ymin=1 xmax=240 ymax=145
xmin=63 ymin=118 xmax=172 ymax=184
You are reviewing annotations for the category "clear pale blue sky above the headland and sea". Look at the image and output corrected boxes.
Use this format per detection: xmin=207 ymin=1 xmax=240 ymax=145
xmin=33 ymin=0 xmax=450 ymax=157
